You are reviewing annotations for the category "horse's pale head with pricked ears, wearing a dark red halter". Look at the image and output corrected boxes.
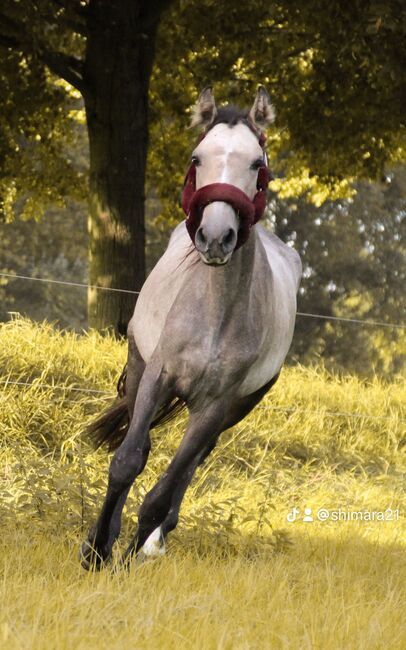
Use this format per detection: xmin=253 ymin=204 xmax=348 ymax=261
xmin=182 ymin=87 xmax=274 ymax=266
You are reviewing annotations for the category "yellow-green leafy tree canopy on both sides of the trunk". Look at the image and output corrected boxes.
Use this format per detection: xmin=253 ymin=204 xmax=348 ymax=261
xmin=0 ymin=0 xmax=406 ymax=225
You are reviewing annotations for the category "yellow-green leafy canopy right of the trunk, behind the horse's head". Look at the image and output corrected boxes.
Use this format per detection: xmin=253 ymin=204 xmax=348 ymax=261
xmin=150 ymin=0 xmax=406 ymax=219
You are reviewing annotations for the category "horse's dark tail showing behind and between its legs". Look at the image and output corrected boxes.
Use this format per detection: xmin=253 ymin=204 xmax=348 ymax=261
xmin=87 ymin=366 xmax=185 ymax=451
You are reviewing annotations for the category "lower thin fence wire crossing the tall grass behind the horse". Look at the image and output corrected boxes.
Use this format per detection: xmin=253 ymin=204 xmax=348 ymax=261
xmin=0 ymin=379 xmax=406 ymax=424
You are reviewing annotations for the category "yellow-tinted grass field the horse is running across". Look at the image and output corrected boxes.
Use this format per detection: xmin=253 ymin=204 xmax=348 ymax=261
xmin=0 ymin=320 xmax=406 ymax=650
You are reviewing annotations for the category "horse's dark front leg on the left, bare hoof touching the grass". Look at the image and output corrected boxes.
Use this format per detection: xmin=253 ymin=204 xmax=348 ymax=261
xmin=81 ymin=364 xmax=168 ymax=569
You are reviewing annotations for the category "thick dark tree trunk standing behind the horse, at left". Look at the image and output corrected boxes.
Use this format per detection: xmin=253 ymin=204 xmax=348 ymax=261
xmin=85 ymin=0 xmax=164 ymax=334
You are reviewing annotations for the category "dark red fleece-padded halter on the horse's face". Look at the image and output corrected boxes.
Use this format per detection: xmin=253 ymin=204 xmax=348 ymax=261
xmin=182 ymin=127 xmax=271 ymax=250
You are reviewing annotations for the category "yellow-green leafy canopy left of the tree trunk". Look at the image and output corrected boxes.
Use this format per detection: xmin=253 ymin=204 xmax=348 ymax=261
xmin=0 ymin=0 xmax=86 ymax=221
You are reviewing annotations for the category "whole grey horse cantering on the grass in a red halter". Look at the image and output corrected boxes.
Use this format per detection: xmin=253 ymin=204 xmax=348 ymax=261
xmin=80 ymin=87 xmax=301 ymax=569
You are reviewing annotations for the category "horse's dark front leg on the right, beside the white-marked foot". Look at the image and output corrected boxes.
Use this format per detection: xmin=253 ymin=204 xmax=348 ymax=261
xmin=124 ymin=402 xmax=225 ymax=560
